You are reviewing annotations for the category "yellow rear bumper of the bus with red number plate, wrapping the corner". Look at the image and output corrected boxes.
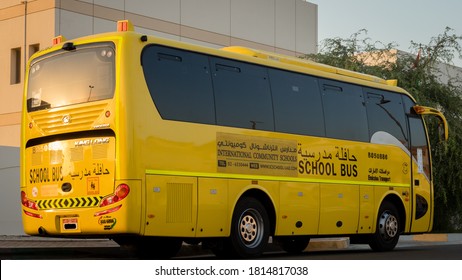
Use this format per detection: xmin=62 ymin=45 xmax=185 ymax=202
xmin=21 ymin=180 xmax=142 ymax=237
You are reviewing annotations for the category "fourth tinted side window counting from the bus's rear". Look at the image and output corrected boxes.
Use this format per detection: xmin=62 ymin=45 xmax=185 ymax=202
xmin=319 ymin=79 xmax=369 ymax=142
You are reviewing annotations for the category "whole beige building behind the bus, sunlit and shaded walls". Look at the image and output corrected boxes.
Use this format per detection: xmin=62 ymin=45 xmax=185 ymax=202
xmin=0 ymin=0 xmax=318 ymax=235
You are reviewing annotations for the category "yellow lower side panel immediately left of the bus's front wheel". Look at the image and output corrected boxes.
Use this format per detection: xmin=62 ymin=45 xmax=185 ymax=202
xmin=319 ymin=184 xmax=359 ymax=234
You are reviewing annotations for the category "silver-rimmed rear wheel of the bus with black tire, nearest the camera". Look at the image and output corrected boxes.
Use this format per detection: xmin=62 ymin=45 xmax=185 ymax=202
xmin=229 ymin=197 xmax=270 ymax=258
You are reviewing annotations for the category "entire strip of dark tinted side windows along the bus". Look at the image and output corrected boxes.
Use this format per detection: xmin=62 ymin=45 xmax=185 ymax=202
xmin=142 ymin=45 xmax=414 ymax=146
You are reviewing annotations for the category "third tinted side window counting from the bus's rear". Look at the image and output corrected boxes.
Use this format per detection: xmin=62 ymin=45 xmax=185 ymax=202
xmin=269 ymin=69 xmax=325 ymax=136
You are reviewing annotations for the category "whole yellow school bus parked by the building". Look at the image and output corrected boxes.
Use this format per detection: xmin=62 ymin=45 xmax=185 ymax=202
xmin=20 ymin=21 xmax=447 ymax=257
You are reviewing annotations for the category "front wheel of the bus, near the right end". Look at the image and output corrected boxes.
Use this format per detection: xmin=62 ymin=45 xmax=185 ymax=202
xmin=369 ymin=201 xmax=401 ymax=251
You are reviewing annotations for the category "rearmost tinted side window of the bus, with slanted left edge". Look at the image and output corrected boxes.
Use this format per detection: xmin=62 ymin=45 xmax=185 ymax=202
xmin=142 ymin=45 xmax=215 ymax=124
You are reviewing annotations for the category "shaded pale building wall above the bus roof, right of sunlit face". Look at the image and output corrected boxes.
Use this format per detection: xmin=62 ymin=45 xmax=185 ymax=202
xmin=57 ymin=0 xmax=317 ymax=55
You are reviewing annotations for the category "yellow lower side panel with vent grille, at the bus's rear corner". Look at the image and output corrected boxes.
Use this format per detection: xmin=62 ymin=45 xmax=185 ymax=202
xmin=144 ymin=175 xmax=197 ymax=237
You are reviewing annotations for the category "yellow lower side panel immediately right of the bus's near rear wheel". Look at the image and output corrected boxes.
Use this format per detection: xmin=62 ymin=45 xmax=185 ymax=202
xmin=276 ymin=182 xmax=319 ymax=235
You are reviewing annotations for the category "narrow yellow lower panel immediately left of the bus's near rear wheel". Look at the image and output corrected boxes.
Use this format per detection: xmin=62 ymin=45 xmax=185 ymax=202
xmin=196 ymin=178 xmax=231 ymax=237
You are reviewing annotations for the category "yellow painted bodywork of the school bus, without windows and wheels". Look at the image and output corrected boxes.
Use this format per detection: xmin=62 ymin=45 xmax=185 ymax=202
xmin=21 ymin=23 xmax=446 ymax=258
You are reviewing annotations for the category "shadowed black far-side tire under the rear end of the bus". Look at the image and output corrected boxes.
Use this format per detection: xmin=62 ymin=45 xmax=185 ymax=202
xmin=114 ymin=237 xmax=183 ymax=259
